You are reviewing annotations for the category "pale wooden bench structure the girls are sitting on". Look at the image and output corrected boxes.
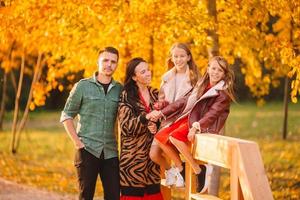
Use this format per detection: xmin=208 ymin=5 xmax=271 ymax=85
xmin=162 ymin=134 xmax=273 ymax=200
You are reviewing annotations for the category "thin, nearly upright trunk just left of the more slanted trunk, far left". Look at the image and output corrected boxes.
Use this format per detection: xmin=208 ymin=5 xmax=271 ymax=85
xmin=10 ymin=52 xmax=25 ymax=154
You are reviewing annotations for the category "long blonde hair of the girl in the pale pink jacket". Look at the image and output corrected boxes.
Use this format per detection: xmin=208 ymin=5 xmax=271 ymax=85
xmin=167 ymin=43 xmax=199 ymax=87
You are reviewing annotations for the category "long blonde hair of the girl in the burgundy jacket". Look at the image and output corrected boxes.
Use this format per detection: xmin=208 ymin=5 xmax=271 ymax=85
xmin=196 ymin=56 xmax=235 ymax=101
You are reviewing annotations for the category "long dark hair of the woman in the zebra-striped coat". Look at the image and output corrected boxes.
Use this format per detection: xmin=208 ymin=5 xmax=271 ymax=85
xmin=123 ymin=57 xmax=147 ymax=115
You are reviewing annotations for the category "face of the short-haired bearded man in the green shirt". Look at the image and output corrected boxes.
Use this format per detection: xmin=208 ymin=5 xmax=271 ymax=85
xmin=98 ymin=52 xmax=118 ymax=76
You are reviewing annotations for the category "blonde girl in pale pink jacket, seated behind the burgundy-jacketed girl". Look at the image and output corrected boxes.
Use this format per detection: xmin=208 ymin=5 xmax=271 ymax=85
xmin=150 ymin=43 xmax=199 ymax=186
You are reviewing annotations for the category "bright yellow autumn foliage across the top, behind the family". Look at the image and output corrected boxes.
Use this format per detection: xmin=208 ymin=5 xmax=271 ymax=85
xmin=0 ymin=0 xmax=300 ymax=108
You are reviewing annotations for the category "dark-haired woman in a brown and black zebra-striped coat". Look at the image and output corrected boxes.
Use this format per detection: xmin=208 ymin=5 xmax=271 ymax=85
xmin=118 ymin=58 xmax=163 ymax=200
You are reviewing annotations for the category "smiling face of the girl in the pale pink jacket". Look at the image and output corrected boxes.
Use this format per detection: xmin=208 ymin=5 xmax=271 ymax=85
xmin=171 ymin=47 xmax=191 ymax=71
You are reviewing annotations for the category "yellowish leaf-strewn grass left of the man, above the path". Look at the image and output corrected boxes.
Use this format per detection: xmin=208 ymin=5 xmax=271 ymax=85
xmin=0 ymin=112 xmax=102 ymax=196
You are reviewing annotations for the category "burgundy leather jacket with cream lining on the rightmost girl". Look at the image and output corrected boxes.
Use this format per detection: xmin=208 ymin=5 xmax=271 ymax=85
xmin=161 ymin=81 xmax=231 ymax=134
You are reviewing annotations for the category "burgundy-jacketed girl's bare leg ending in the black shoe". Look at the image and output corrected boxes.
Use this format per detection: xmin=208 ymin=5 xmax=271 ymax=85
xmin=169 ymin=136 xmax=201 ymax=174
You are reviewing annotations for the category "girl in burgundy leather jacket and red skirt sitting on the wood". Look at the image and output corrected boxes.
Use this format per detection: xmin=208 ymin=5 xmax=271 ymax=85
xmin=150 ymin=56 xmax=234 ymax=193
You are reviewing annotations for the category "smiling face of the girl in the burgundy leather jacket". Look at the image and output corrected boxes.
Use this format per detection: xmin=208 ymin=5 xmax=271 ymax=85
xmin=207 ymin=60 xmax=225 ymax=86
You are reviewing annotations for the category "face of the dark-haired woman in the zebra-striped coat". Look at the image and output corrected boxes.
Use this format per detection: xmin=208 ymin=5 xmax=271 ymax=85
xmin=132 ymin=62 xmax=151 ymax=86
